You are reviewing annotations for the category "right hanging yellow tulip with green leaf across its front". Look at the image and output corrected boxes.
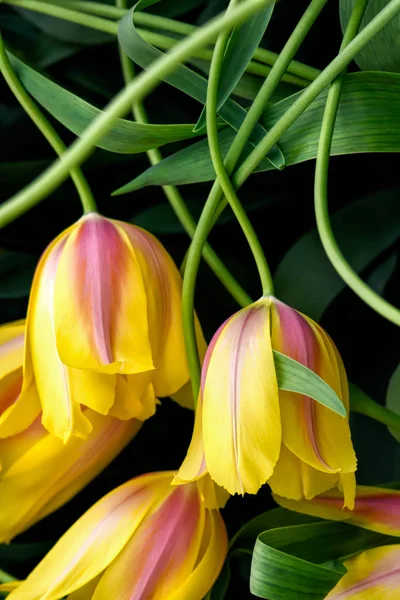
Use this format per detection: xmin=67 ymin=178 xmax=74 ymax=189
xmin=175 ymin=297 xmax=356 ymax=507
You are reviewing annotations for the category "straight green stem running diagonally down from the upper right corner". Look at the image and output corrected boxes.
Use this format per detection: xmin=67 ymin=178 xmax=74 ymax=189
xmin=234 ymin=0 xmax=400 ymax=187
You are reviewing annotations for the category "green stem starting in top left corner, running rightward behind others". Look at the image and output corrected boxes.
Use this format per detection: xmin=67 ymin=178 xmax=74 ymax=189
xmin=4 ymin=0 xmax=309 ymax=87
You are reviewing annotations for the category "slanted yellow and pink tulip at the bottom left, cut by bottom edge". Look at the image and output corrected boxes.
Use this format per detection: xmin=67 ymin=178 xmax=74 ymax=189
xmin=8 ymin=472 xmax=227 ymax=600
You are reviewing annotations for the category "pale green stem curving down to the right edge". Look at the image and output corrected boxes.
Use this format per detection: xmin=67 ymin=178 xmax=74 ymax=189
xmin=314 ymin=0 xmax=400 ymax=325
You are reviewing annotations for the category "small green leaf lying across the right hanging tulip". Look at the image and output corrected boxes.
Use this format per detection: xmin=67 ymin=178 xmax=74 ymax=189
xmin=273 ymin=350 xmax=347 ymax=417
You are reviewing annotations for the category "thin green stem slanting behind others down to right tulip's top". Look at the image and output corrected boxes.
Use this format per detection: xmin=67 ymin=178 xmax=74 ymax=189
xmin=116 ymin=0 xmax=252 ymax=306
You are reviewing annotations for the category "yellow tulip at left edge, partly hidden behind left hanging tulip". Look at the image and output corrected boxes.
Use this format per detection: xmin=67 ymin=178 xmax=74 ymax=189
xmin=0 ymin=321 xmax=142 ymax=543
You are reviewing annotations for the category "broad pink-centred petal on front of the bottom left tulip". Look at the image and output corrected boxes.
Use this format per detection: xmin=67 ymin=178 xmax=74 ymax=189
xmin=93 ymin=484 xmax=205 ymax=600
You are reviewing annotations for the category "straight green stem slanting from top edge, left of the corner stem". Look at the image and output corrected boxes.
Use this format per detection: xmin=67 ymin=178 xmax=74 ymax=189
xmin=207 ymin=0 xmax=328 ymax=230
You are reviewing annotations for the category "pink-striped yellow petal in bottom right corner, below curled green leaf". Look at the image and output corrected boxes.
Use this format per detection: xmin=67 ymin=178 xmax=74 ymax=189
xmin=327 ymin=545 xmax=400 ymax=600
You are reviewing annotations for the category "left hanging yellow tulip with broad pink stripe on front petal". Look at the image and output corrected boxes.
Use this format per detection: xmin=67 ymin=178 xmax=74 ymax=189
xmin=21 ymin=213 xmax=204 ymax=441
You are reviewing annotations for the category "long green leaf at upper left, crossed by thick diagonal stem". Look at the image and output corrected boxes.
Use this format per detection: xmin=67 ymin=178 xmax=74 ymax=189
xmin=9 ymin=53 xmax=203 ymax=154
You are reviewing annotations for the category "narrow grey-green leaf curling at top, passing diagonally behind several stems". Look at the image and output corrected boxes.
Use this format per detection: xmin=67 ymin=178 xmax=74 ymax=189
xmin=118 ymin=0 xmax=285 ymax=169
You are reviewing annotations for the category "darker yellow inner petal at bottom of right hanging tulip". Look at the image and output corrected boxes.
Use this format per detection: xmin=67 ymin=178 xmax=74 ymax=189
xmin=268 ymin=444 xmax=339 ymax=501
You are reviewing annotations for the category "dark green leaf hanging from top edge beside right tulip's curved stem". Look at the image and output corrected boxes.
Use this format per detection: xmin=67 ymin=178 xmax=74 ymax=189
xmin=195 ymin=2 xmax=275 ymax=130
